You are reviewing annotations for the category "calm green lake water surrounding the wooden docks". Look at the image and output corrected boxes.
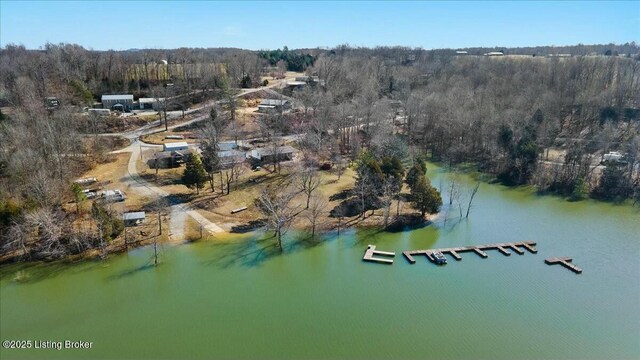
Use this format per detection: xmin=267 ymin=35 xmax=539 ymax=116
xmin=0 ymin=168 xmax=640 ymax=360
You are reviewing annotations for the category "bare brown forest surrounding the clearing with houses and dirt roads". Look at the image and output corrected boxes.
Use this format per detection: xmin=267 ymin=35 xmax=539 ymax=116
xmin=0 ymin=43 xmax=640 ymax=258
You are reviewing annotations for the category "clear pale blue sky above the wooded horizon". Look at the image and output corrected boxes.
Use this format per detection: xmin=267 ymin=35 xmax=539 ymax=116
xmin=0 ymin=0 xmax=640 ymax=50
